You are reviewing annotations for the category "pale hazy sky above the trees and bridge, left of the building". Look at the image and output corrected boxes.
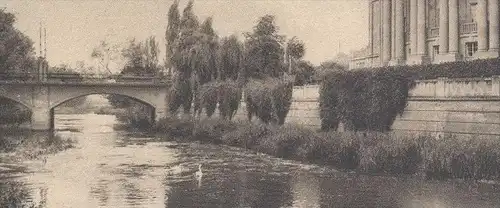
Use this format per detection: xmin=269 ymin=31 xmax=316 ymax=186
xmin=0 ymin=0 xmax=368 ymax=70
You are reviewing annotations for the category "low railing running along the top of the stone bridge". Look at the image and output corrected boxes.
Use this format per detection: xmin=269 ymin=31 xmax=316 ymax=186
xmin=0 ymin=72 xmax=171 ymax=83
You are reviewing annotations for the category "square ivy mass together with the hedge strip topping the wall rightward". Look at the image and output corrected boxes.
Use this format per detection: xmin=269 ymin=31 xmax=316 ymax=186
xmin=320 ymin=58 xmax=500 ymax=132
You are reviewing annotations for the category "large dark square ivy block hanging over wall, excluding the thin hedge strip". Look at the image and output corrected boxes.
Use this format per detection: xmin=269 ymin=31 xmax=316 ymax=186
xmin=320 ymin=70 xmax=414 ymax=132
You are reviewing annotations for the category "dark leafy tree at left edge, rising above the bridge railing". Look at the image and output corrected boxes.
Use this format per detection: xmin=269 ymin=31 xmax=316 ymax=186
xmin=0 ymin=10 xmax=37 ymax=73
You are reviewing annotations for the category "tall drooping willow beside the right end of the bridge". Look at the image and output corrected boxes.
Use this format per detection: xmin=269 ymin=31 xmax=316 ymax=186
xmin=168 ymin=1 xmax=219 ymax=118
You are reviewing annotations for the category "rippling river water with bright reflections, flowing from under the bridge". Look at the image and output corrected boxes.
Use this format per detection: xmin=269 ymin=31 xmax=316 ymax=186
xmin=0 ymin=114 xmax=500 ymax=208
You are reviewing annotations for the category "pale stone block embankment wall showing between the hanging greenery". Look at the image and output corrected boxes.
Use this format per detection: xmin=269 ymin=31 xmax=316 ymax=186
xmin=231 ymin=77 xmax=500 ymax=137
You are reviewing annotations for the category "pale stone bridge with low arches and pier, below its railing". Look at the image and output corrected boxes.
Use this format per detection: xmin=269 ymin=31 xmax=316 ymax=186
xmin=0 ymin=80 xmax=169 ymax=130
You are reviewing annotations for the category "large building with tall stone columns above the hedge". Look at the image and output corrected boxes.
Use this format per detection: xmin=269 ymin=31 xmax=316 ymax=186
xmin=350 ymin=0 xmax=500 ymax=68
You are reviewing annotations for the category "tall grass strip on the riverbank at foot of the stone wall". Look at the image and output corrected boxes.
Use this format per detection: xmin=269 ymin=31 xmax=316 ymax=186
xmin=154 ymin=118 xmax=500 ymax=180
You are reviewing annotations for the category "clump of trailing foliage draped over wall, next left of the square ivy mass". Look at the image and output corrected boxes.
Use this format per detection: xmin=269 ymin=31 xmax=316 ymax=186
xmin=244 ymin=76 xmax=294 ymax=125
